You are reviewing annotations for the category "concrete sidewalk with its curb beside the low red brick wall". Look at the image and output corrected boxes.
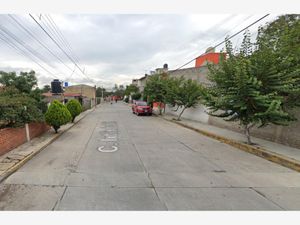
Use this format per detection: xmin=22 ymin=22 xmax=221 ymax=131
xmin=0 ymin=106 xmax=95 ymax=182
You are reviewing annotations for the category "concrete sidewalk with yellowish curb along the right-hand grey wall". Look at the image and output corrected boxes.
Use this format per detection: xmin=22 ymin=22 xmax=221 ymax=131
xmin=161 ymin=114 xmax=300 ymax=172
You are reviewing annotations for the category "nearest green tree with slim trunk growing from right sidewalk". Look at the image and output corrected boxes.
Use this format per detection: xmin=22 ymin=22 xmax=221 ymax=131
xmin=204 ymin=32 xmax=291 ymax=144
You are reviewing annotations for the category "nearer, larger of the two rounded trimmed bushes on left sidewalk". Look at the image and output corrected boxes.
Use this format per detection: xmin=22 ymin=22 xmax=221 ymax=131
xmin=45 ymin=100 xmax=72 ymax=133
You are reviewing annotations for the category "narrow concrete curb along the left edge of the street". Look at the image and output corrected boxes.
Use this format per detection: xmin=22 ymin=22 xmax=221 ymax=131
xmin=0 ymin=108 xmax=95 ymax=183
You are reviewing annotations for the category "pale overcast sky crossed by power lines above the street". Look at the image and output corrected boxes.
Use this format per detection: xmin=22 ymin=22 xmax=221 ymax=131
xmin=0 ymin=14 xmax=277 ymax=87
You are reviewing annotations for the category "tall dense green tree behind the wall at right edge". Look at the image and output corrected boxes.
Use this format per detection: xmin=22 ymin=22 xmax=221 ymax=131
xmin=250 ymin=15 xmax=300 ymax=110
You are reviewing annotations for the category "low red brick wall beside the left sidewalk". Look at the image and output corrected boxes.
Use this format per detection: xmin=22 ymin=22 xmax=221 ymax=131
xmin=0 ymin=123 xmax=50 ymax=155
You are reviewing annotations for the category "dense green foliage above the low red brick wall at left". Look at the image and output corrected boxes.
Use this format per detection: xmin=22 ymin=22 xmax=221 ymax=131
xmin=0 ymin=86 xmax=44 ymax=128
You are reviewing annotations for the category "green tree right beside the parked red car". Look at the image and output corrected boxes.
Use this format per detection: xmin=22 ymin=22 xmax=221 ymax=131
xmin=144 ymin=74 xmax=167 ymax=115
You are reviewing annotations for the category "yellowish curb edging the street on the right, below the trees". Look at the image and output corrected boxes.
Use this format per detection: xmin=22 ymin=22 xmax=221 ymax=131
xmin=161 ymin=115 xmax=300 ymax=172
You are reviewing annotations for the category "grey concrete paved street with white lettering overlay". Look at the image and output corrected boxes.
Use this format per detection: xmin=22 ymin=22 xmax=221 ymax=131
xmin=0 ymin=102 xmax=300 ymax=210
